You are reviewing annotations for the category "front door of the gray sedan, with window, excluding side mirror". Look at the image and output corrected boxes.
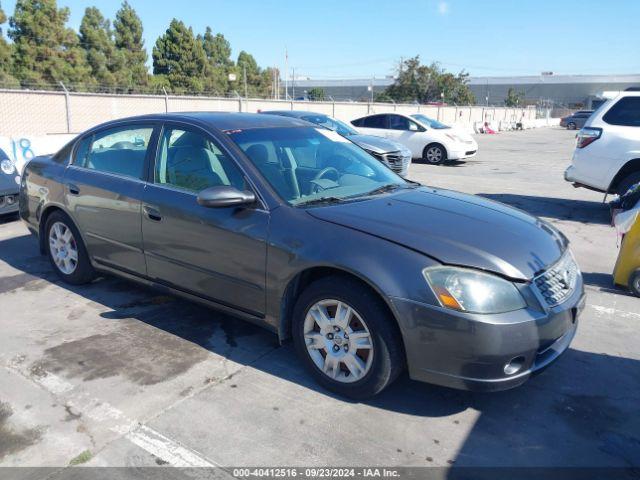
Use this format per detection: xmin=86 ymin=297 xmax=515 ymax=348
xmin=142 ymin=124 xmax=269 ymax=316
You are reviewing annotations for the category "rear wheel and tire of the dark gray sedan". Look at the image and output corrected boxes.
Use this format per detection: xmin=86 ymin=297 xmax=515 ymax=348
xmin=44 ymin=211 xmax=96 ymax=285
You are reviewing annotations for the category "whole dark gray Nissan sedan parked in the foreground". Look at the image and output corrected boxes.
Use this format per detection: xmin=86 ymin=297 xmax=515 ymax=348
xmin=19 ymin=113 xmax=584 ymax=398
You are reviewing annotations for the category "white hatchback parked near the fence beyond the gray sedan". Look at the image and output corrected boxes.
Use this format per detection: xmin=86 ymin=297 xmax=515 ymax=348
xmin=351 ymin=113 xmax=478 ymax=165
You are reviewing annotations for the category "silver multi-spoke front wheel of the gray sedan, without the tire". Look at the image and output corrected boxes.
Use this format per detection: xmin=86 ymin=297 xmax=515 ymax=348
xmin=304 ymin=299 xmax=374 ymax=383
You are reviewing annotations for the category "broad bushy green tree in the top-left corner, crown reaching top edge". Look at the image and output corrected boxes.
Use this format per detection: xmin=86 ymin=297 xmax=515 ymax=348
xmin=9 ymin=0 xmax=90 ymax=87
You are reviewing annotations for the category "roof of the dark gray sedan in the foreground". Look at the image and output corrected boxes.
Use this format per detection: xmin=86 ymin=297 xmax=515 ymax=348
xmin=88 ymin=112 xmax=309 ymax=131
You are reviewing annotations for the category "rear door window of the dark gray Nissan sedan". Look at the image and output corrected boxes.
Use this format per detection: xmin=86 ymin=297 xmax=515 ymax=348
xmin=74 ymin=125 xmax=153 ymax=179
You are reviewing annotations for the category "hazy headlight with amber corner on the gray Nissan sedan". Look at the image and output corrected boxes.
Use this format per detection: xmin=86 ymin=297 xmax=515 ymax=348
xmin=422 ymin=267 xmax=527 ymax=313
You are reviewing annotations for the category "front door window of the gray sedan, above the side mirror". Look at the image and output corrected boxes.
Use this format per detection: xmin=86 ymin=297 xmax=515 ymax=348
xmin=155 ymin=128 xmax=245 ymax=193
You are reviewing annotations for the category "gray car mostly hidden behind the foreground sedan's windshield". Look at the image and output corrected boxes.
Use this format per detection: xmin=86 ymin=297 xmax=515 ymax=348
xmin=261 ymin=110 xmax=411 ymax=177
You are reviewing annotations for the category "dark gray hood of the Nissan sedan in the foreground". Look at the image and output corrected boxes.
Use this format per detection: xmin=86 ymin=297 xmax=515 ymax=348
xmin=308 ymin=187 xmax=568 ymax=280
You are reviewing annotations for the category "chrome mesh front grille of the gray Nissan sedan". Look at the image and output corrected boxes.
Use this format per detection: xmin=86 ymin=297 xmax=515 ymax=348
xmin=534 ymin=250 xmax=580 ymax=307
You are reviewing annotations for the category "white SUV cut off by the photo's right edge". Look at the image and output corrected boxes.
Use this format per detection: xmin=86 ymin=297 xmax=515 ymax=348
xmin=564 ymin=91 xmax=640 ymax=194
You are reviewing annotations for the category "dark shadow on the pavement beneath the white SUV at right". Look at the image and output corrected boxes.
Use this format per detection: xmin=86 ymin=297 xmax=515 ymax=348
xmin=478 ymin=193 xmax=611 ymax=225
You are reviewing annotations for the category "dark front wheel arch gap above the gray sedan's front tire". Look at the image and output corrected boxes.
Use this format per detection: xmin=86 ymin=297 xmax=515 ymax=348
xmin=278 ymin=266 xmax=404 ymax=347
